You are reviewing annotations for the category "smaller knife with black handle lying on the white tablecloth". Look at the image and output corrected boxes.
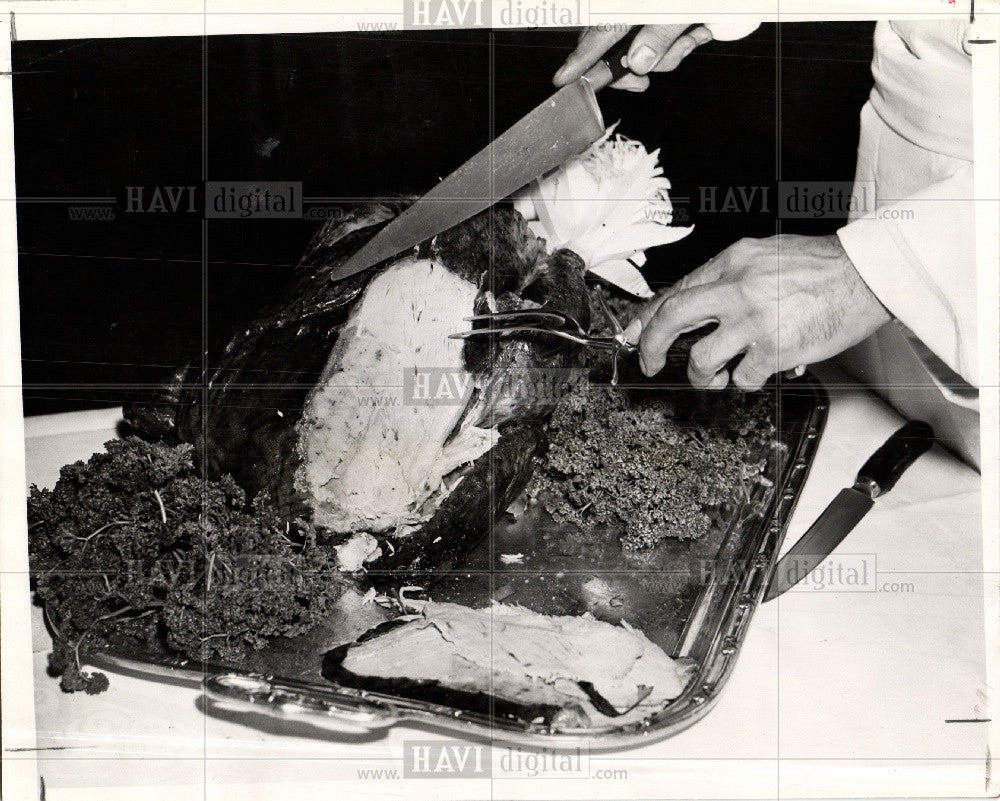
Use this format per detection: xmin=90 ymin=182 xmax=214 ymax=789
xmin=764 ymin=420 xmax=934 ymax=603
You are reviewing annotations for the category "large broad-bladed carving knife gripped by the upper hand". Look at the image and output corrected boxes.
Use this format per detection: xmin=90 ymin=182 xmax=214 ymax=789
xmin=330 ymin=44 xmax=629 ymax=281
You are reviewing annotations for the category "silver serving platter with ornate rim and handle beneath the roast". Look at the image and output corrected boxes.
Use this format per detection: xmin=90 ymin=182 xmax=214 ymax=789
xmin=89 ymin=373 xmax=829 ymax=748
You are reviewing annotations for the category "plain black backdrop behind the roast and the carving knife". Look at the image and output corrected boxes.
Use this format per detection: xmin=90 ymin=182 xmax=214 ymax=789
xmin=13 ymin=23 xmax=872 ymax=415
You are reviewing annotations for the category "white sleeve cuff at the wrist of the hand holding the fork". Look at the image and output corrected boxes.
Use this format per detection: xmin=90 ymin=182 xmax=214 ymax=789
xmin=837 ymin=164 xmax=979 ymax=385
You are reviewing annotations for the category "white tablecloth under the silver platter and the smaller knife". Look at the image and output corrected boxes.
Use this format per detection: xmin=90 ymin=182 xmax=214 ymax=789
xmin=6 ymin=372 xmax=995 ymax=799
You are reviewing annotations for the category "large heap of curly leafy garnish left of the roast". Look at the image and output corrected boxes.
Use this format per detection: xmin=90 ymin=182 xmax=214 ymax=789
xmin=28 ymin=437 xmax=343 ymax=693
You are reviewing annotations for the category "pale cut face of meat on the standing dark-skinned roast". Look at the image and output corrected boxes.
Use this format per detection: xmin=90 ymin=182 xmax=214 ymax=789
xmin=296 ymin=259 xmax=499 ymax=533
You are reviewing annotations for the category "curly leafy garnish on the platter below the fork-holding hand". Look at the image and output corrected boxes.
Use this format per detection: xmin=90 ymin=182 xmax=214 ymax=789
xmin=528 ymin=386 xmax=775 ymax=551
